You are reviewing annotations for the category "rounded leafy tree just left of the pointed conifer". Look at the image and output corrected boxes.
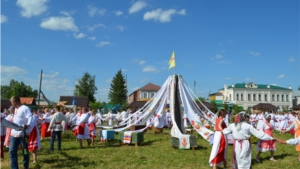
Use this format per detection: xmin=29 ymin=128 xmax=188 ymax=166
xmin=74 ymin=72 xmax=98 ymax=102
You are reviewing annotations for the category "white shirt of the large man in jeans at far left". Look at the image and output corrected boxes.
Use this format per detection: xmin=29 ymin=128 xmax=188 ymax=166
xmin=11 ymin=105 xmax=33 ymax=137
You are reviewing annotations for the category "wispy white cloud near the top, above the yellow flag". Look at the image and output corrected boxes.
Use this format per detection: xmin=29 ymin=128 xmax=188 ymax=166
xmin=144 ymin=8 xmax=185 ymax=23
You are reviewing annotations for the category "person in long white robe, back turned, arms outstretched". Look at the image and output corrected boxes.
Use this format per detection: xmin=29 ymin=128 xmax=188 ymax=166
xmin=222 ymin=112 xmax=274 ymax=169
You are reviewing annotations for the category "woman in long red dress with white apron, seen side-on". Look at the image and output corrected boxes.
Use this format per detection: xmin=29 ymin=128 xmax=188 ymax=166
xmin=209 ymin=109 xmax=227 ymax=169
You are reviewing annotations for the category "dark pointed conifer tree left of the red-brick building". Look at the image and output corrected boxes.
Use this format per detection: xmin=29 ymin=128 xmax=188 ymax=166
xmin=108 ymin=70 xmax=127 ymax=107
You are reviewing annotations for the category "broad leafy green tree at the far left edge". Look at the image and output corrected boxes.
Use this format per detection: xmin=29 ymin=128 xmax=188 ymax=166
xmin=1 ymin=79 xmax=38 ymax=99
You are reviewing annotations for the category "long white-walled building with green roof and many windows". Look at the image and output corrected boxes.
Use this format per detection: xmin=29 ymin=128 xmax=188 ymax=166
xmin=211 ymin=82 xmax=293 ymax=110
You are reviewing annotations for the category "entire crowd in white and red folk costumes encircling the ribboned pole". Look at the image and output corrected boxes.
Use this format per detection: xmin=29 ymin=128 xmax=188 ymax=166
xmin=0 ymin=96 xmax=300 ymax=169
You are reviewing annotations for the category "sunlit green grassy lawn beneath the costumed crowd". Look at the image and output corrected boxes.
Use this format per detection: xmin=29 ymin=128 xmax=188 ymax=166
xmin=1 ymin=129 xmax=300 ymax=169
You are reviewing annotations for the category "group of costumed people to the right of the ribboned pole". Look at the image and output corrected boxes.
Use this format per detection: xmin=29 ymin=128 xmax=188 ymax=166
xmin=209 ymin=109 xmax=300 ymax=169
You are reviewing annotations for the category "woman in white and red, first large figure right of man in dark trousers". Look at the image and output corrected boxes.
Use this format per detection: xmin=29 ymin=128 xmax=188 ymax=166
xmin=77 ymin=107 xmax=91 ymax=148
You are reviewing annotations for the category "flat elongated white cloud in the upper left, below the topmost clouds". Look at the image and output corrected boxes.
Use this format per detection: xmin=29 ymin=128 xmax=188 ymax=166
xmin=40 ymin=16 xmax=78 ymax=31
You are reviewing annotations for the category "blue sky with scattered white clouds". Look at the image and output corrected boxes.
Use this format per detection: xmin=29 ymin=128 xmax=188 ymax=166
xmin=1 ymin=0 xmax=300 ymax=101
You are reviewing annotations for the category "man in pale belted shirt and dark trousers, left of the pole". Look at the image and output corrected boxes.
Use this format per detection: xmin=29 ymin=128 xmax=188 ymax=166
xmin=48 ymin=106 xmax=69 ymax=151
